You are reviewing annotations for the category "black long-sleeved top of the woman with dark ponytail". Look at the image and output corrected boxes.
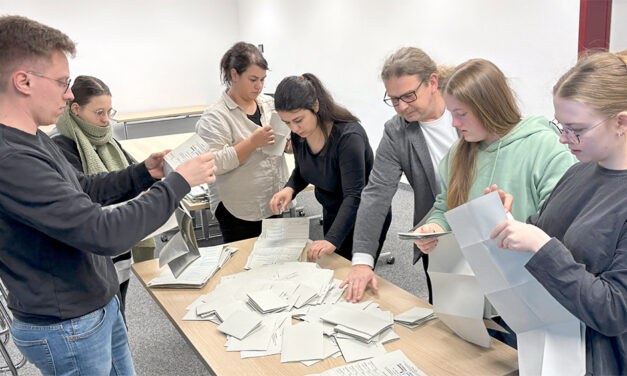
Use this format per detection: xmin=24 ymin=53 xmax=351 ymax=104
xmin=286 ymin=123 xmax=374 ymax=253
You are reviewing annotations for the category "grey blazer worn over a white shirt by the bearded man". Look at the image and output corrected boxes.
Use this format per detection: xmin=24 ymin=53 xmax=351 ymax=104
xmin=353 ymin=115 xmax=439 ymax=264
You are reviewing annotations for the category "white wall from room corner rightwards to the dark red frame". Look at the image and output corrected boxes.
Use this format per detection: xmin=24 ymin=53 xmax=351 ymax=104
xmin=238 ymin=0 xmax=580 ymax=147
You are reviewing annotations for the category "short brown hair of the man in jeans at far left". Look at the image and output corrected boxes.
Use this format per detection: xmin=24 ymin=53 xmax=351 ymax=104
xmin=0 ymin=16 xmax=76 ymax=92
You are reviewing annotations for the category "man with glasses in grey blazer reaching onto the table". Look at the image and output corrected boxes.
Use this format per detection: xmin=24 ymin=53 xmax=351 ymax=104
xmin=341 ymin=47 xmax=458 ymax=302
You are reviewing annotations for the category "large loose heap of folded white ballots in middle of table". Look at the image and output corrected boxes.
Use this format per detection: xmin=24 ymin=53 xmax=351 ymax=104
xmin=183 ymin=262 xmax=440 ymax=366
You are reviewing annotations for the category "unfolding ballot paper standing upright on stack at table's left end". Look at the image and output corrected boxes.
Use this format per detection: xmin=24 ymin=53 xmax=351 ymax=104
xmin=159 ymin=207 xmax=200 ymax=278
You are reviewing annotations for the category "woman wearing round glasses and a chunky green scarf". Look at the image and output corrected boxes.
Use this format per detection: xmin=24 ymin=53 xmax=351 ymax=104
xmin=53 ymin=76 xmax=154 ymax=316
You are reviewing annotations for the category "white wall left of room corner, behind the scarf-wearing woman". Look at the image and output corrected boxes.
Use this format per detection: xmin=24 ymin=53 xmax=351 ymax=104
xmin=0 ymin=0 xmax=239 ymax=112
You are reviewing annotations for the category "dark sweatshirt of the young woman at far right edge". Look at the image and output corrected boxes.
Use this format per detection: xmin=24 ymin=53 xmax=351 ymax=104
xmin=514 ymin=163 xmax=627 ymax=375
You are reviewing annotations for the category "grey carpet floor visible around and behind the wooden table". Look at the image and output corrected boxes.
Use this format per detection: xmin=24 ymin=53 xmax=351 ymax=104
xmin=7 ymin=184 xmax=427 ymax=375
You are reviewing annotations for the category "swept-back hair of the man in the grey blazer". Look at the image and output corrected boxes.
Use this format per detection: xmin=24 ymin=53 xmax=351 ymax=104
xmin=381 ymin=47 xmax=453 ymax=90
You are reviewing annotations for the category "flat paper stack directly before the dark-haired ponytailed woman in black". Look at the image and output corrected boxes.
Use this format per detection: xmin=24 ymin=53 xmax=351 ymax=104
xmin=245 ymin=218 xmax=309 ymax=269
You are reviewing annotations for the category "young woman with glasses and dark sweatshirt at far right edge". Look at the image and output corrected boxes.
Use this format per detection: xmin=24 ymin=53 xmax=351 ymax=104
xmin=491 ymin=51 xmax=627 ymax=375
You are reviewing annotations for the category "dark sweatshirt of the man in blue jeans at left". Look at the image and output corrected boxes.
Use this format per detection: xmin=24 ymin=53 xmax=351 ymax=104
xmin=0 ymin=124 xmax=190 ymax=324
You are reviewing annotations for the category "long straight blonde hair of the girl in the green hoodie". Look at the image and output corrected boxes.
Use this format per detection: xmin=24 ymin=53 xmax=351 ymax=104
xmin=444 ymin=59 xmax=521 ymax=210
